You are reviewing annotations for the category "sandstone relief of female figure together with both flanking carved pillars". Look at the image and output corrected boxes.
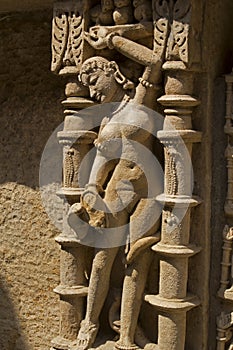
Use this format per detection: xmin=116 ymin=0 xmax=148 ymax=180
xmin=52 ymin=0 xmax=201 ymax=350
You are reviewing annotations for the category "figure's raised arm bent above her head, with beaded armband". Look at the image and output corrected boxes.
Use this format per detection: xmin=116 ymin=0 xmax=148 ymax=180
xmin=85 ymin=22 xmax=164 ymax=109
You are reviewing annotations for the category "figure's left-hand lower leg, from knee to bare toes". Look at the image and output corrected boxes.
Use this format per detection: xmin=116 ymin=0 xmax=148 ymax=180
xmin=74 ymin=247 xmax=118 ymax=350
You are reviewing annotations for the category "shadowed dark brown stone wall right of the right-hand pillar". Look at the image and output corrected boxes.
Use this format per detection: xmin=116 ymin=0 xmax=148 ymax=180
xmin=186 ymin=0 xmax=233 ymax=350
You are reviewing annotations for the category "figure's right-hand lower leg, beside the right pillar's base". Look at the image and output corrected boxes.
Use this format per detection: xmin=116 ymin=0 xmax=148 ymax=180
xmin=116 ymin=248 xmax=153 ymax=349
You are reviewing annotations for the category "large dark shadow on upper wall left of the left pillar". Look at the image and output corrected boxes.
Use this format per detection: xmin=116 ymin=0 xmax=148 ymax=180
xmin=0 ymin=8 xmax=65 ymax=188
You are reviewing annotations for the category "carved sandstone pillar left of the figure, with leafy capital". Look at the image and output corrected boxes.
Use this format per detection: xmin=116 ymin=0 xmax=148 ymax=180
xmin=51 ymin=1 xmax=96 ymax=350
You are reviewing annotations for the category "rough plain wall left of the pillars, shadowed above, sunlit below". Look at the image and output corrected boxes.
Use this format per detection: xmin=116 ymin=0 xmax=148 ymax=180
xmin=0 ymin=9 xmax=64 ymax=350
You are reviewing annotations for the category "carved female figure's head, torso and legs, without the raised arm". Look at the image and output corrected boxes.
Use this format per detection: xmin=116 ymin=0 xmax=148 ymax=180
xmin=70 ymin=57 xmax=162 ymax=350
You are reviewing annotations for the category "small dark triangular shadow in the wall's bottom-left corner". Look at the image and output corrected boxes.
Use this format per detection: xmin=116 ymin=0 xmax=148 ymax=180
xmin=0 ymin=276 xmax=29 ymax=350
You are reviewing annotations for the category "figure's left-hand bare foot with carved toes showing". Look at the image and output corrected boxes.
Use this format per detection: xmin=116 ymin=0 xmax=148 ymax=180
xmin=71 ymin=320 xmax=99 ymax=350
